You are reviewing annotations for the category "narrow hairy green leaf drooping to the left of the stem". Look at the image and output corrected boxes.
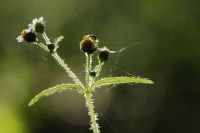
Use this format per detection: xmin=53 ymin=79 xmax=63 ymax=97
xmin=28 ymin=84 xmax=81 ymax=107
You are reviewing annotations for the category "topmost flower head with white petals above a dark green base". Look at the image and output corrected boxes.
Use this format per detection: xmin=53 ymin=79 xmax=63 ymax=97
xmin=28 ymin=17 xmax=46 ymax=33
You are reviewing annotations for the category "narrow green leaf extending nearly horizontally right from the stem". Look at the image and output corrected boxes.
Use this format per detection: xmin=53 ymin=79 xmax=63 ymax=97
xmin=93 ymin=77 xmax=154 ymax=88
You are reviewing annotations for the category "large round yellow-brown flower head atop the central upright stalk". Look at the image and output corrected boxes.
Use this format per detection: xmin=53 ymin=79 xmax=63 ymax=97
xmin=80 ymin=35 xmax=99 ymax=54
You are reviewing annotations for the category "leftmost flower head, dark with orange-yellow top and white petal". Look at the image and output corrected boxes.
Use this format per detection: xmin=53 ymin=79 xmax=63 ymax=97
xmin=16 ymin=29 xmax=37 ymax=42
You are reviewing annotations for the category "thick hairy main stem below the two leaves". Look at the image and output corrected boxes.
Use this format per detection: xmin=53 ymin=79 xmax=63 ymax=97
xmin=85 ymin=92 xmax=100 ymax=133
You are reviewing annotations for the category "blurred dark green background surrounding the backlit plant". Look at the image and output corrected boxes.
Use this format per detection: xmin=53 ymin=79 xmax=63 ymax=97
xmin=0 ymin=0 xmax=200 ymax=133
